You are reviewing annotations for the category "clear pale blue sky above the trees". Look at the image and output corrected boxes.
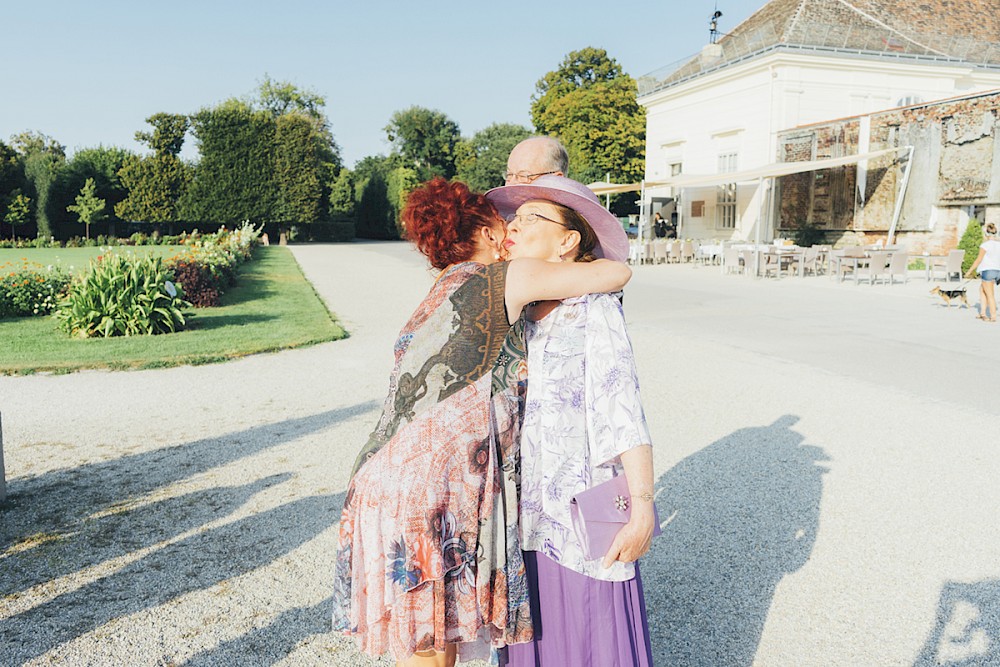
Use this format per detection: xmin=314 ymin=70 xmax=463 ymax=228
xmin=0 ymin=0 xmax=765 ymax=166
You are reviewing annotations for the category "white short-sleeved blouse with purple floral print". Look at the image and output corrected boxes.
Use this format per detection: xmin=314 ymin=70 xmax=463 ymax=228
xmin=520 ymin=294 xmax=650 ymax=581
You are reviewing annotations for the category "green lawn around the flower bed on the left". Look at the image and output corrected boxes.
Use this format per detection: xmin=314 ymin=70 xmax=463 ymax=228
xmin=0 ymin=246 xmax=347 ymax=374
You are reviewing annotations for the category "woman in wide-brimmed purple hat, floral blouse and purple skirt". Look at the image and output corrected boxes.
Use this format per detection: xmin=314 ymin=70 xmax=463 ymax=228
xmin=486 ymin=176 xmax=655 ymax=667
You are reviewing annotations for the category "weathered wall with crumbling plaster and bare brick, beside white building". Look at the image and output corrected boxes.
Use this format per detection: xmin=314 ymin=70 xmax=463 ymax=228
xmin=778 ymin=91 xmax=1000 ymax=253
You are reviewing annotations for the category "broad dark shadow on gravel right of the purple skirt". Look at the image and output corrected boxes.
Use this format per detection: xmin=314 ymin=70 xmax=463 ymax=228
xmin=641 ymin=415 xmax=829 ymax=667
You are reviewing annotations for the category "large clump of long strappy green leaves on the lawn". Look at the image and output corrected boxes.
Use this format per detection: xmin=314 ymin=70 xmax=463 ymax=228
xmin=55 ymin=253 xmax=191 ymax=338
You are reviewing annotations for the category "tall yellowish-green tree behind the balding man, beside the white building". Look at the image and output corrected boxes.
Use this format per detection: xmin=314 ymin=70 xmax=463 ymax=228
xmin=531 ymin=47 xmax=646 ymax=182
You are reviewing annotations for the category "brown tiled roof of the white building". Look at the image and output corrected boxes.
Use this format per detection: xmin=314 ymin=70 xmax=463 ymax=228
xmin=639 ymin=0 xmax=1000 ymax=97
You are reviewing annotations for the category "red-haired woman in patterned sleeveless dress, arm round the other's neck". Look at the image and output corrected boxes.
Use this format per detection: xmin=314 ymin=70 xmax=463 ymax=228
xmin=333 ymin=178 xmax=631 ymax=665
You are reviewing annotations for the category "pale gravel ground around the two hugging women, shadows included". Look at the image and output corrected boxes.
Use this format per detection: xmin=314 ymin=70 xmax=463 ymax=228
xmin=0 ymin=243 xmax=1000 ymax=667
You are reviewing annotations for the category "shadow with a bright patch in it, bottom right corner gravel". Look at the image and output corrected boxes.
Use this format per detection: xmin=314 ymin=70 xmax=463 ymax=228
xmin=913 ymin=579 xmax=1000 ymax=667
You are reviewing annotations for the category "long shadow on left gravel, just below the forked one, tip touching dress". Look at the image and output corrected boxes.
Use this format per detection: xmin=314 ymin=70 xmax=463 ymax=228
xmin=0 ymin=493 xmax=344 ymax=665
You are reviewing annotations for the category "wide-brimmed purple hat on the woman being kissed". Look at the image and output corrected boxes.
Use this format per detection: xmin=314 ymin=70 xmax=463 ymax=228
xmin=486 ymin=176 xmax=628 ymax=262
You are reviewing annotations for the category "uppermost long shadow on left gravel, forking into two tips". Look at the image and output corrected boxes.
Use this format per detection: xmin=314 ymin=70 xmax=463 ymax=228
xmin=0 ymin=401 xmax=377 ymax=628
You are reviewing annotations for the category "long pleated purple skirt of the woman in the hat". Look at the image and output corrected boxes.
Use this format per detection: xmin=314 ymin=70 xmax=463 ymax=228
xmin=500 ymin=551 xmax=653 ymax=667
